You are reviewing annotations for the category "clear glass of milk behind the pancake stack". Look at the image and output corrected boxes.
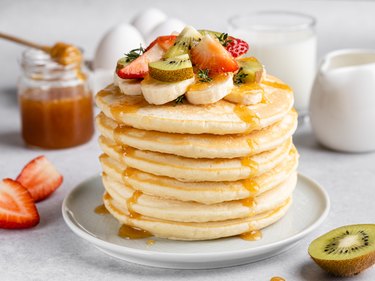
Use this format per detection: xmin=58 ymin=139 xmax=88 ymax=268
xmin=229 ymin=11 xmax=317 ymax=115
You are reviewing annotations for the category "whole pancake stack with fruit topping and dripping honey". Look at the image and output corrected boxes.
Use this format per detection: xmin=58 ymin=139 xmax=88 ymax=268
xmin=96 ymin=26 xmax=299 ymax=240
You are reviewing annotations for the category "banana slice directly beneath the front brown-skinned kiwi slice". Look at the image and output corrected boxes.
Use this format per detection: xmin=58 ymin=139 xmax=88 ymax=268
xmin=141 ymin=76 xmax=194 ymax=105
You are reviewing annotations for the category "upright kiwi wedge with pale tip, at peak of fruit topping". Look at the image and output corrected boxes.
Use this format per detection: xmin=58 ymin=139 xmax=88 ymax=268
xmin=164 ymin=26 xmax=202 ymax=58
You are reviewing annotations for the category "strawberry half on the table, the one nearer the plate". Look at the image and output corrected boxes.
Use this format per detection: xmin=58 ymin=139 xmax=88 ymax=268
xmin=16 ymin=155 xmax=63 ymax=202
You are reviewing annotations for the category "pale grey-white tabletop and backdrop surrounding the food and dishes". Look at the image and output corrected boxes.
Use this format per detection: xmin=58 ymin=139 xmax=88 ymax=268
xmin=0 ymin=0 xmax=375 ymax=281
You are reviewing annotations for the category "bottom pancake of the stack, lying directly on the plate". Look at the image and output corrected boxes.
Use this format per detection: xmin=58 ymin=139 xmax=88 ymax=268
xmin=103 ymin=193 xmax=292 ymax=240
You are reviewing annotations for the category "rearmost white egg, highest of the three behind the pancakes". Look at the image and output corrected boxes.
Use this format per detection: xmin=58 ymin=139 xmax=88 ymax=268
xmin=132 ymin=8 xmax=167 ymax=36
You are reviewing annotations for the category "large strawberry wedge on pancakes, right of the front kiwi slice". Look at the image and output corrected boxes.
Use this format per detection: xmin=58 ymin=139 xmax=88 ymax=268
xmin=190 ymin=34 xmax=238 ymax=73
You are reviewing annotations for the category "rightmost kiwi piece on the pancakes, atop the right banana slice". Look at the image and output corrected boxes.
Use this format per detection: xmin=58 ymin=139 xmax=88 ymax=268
xmin=233 ymin=57 xmax=264 ymax=85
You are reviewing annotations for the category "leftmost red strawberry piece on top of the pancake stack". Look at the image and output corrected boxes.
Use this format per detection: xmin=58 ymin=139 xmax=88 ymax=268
xmin=117 ymin=44 xmax=165 ymax=79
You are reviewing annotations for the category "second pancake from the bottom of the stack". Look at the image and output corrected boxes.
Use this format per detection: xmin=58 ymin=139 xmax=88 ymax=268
xmin=102 ymin=173 xmax=297 ymax=222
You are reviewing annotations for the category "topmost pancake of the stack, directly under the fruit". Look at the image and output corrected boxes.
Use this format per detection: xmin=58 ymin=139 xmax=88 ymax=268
xmin=96 ymin=76 xmax=294 ymax=135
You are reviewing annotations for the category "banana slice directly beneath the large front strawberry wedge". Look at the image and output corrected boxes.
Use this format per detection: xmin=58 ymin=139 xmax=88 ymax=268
xmin=185 ymin=73 xmax=233 ymax=104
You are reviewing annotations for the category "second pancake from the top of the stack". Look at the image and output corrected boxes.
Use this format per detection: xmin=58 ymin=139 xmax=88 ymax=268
xmin=96 ymin=110 xmax=297 ymax=158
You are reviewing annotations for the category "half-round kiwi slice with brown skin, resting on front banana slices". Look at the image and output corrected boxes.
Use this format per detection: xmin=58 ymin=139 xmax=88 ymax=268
xmin=148 ymin=54 xmax=194 ymax=82
